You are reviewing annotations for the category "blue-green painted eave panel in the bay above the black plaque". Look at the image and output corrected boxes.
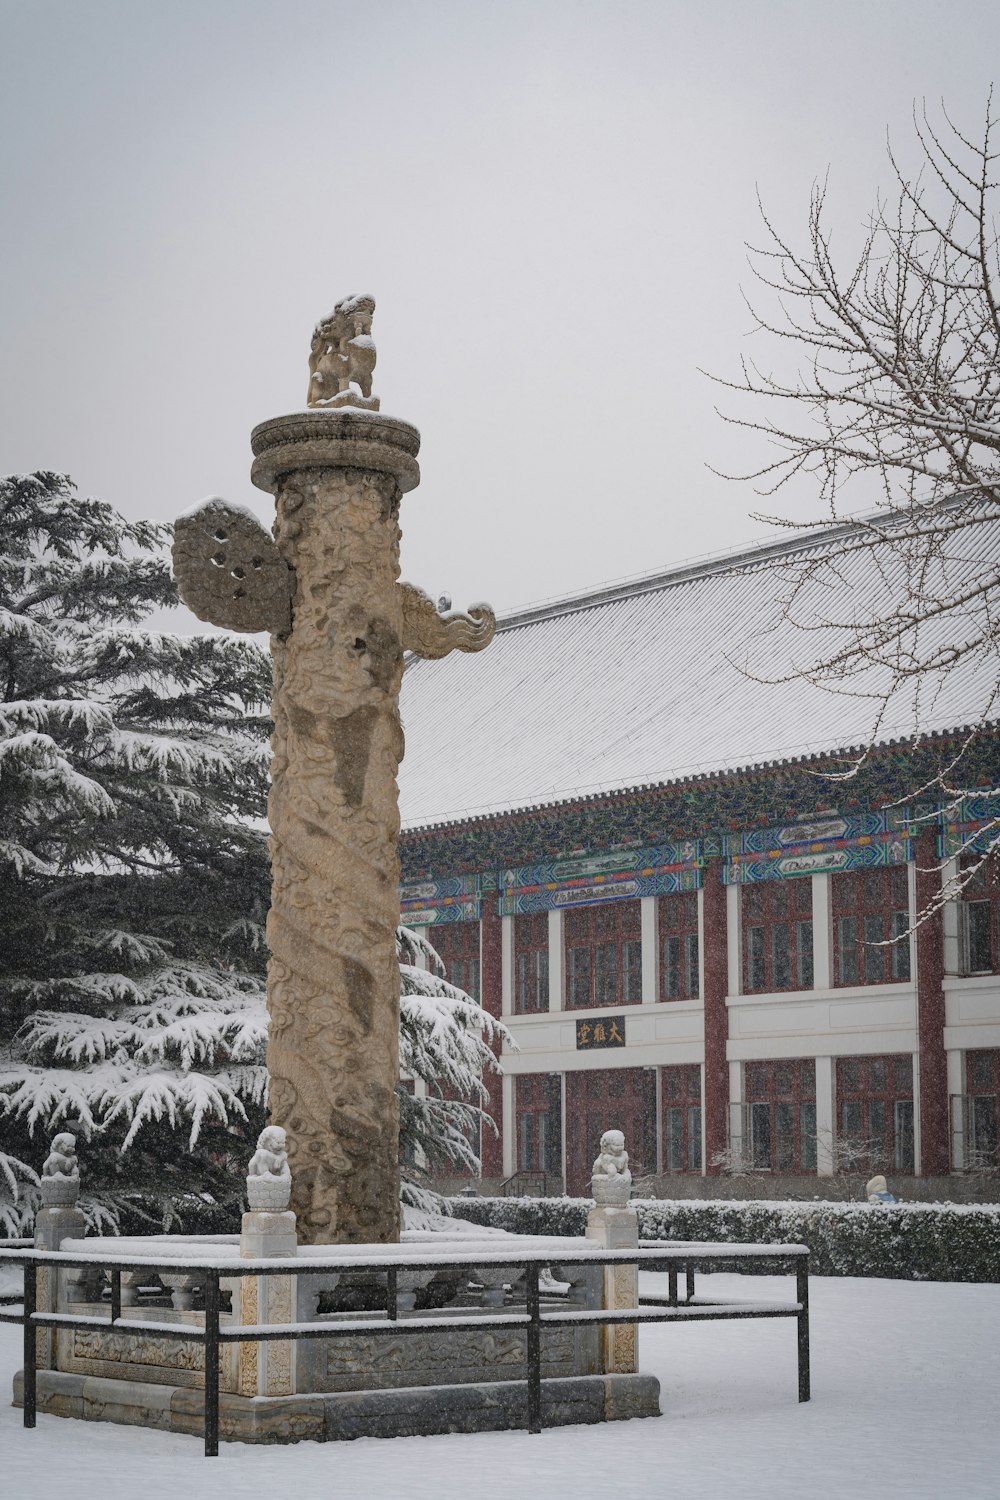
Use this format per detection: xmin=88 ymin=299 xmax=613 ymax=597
xmin=499 ymin=839 xmax=703 ymax=917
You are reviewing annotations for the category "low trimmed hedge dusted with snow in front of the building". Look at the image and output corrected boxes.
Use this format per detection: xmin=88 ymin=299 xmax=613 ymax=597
xmin=450 ymin=1199 xmax=1000 ymax=1281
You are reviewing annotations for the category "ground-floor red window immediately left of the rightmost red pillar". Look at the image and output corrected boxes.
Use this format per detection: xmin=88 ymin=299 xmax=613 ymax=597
xmin=837 ymin=1055 xmax=913 ymax=1172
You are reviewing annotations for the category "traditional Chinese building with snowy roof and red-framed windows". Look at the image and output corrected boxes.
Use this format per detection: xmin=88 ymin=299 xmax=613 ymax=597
xmin=400 ymin=516 xmax=1000 ymax=1193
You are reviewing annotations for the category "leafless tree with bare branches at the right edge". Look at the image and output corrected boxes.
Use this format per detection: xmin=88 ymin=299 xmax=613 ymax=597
xmin=721 ymin=93 xmax=1000 ymax=888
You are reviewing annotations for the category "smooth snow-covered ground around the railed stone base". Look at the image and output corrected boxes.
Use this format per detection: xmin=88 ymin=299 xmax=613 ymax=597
xmin=0 ymin=1277 xmax=1000 ymax=1500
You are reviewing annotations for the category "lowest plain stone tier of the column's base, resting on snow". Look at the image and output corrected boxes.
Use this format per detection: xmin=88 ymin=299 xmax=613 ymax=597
xmin=13 ymin=1370 xmax=660 ymax=1443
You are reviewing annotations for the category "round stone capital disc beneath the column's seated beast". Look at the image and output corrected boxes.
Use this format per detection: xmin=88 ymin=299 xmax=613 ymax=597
xmin=250 ymin=407 xmax=420 ymax=495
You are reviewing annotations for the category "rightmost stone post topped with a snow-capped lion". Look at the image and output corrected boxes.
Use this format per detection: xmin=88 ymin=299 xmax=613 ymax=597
xmin=586 ymin=1130 xmax=639 ymax=1376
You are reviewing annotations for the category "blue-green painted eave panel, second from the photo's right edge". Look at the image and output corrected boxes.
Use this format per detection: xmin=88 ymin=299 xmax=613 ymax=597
xmin=724 ymin=807 xmax=919 ymax=885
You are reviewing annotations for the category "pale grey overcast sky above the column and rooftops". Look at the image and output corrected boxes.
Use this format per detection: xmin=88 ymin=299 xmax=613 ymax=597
xmin=0 ymin=0 xmax=1000 ymax=624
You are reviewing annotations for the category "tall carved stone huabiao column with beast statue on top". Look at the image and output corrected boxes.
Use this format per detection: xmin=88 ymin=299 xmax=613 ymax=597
xmin=174 ymin=297 xmax=495 ymax=1244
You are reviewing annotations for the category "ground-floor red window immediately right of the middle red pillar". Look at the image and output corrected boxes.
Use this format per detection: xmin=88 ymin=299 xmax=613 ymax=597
xmin=744 ymin=1058 xmax=816 ymax=1172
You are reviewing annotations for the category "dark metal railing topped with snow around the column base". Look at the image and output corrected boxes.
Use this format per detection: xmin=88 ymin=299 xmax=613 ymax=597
xmin=0 ymin=1241 xmax=810 ymax=1458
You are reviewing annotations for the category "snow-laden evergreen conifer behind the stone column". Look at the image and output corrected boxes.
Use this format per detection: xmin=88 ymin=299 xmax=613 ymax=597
xmin=0 ymin=473 xmax=509 ymax=1233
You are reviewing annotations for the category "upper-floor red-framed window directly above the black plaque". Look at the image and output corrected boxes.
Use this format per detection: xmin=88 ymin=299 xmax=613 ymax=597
xmin=564 ymin=902 xmax=642 ymax=1010
